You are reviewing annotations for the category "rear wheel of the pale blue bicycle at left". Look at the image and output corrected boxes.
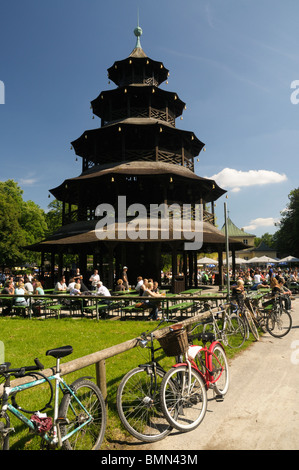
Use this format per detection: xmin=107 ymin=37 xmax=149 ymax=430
xmin=59 ymin=378 xmax=107 ymax=450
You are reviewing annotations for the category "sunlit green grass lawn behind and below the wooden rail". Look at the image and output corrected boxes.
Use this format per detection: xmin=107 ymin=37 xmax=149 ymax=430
xmin=0 ymin=318 xmax=258 ymax=449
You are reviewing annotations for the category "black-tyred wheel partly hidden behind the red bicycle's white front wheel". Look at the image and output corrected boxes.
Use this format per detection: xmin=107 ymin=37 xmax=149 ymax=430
xmin=116 ymin=367 xmax=172 ymax=442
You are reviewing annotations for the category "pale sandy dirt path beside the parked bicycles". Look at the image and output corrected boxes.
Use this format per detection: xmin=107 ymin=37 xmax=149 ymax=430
xmin=122 ymin=298 xmax=299 ymax=451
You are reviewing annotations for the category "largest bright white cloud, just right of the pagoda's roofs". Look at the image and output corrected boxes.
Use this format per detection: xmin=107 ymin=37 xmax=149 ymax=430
xmin=210 ymin=168 xmax=287 ymax=192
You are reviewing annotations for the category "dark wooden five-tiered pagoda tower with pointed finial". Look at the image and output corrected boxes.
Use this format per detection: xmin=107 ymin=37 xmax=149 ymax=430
xmin=31 ymin=26 xmax=244 ymax=291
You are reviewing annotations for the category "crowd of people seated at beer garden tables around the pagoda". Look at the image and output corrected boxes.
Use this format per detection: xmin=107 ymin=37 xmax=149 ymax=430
xmin=0 ymin=266 xmax=299 ymax=320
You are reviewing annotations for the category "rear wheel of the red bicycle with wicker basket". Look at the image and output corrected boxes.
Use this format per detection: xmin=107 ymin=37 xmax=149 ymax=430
xmin=209 ymin=344 xmax=229 ymax=395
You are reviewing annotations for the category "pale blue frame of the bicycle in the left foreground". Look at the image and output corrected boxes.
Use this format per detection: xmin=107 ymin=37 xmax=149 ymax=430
xmin=0 ymin=373 xmax=92 ymax=446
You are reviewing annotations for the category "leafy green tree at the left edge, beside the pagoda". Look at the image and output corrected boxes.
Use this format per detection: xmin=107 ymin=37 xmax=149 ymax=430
xmin=0 ymin=180 xmax=47 ymax=267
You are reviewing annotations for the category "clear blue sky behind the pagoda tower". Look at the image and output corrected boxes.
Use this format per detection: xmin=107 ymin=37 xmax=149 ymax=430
xmin=0 ymin=0 xmax=299 ymax=236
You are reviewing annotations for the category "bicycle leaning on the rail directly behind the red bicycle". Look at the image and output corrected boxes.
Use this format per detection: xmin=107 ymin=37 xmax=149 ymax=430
xmin=203 ymin=303 xmax=246 ymax=348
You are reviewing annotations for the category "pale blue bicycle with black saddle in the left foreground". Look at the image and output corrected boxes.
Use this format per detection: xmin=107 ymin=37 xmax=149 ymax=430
xmin=0 ymin=346 xmax=107 ymax=450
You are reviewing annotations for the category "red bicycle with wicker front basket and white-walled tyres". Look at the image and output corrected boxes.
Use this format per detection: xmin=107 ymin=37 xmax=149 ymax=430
xmin=160 ymin=325 xmax=229 ymax=432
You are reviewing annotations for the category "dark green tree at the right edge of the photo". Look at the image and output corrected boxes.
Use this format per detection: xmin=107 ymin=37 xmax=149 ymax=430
xmin=273 ymin=188 xmax=299 ymax=257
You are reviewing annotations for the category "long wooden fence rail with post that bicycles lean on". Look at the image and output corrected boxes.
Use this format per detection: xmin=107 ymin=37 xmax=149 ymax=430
xmin=0 ymin=308 xmax=219 ymax=399
